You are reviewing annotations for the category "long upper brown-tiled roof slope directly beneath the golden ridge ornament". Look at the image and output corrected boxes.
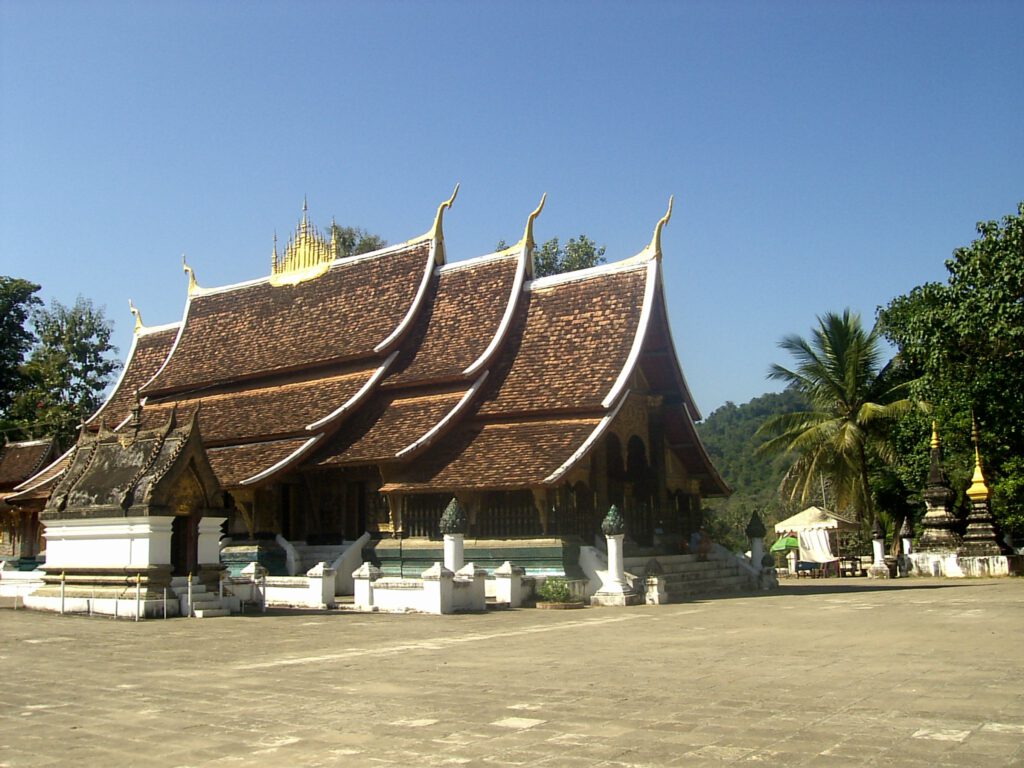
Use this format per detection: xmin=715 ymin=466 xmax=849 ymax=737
xmin=145 ymin=242 xmax=432 ymax=394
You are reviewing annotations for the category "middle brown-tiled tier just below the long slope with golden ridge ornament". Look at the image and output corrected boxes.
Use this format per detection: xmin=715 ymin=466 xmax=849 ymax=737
xmin=141 ymin=368 xmax=376 ymax=446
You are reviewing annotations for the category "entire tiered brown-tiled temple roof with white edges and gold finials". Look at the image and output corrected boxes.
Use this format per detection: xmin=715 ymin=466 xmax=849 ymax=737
xmin=9 ymin=196 xmax=728 ymax=496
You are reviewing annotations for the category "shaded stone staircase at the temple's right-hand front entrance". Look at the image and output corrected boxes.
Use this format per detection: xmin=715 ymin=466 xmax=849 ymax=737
xmin=627 ymin=555 xmax=751 ymax=604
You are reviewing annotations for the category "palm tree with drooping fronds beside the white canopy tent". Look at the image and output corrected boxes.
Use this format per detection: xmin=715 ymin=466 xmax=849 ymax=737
xmin=758 ymin=309 xmax=911 ymax=522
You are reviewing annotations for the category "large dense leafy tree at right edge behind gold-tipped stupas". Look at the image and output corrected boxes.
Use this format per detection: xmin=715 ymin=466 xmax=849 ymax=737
xmin=879 ymin=203 xmax=1024 ymax=536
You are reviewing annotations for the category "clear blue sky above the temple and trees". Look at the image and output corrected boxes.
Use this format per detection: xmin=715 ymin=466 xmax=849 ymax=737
xmin=0 ymin=0 xmax=1024 ymax=415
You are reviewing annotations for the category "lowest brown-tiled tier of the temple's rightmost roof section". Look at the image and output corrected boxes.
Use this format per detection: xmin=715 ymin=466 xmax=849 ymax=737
xmin=382 ymin=419 xmax=600 ymax=493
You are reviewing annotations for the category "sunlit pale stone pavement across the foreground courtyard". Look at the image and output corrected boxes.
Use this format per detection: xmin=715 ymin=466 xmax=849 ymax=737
xmin=0 ymin=579 xmax=1024 ymax=768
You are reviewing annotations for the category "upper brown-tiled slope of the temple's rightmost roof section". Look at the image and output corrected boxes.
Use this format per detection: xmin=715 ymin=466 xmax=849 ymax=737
xmin=479 ymin=264 xmax=647 ymax=417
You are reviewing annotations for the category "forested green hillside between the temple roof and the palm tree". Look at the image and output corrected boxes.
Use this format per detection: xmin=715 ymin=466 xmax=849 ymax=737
xmin=697 ymin=390 xmax=807 ymax=550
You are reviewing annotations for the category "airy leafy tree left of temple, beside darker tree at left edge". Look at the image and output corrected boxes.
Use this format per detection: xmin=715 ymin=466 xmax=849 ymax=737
xmin=13 ymin=297 xmax=120 ymax=444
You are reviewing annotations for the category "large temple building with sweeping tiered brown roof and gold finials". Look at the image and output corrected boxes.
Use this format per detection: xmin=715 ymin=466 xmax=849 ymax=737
xmin=9 ymin=187 xmax=730 ymax=589
